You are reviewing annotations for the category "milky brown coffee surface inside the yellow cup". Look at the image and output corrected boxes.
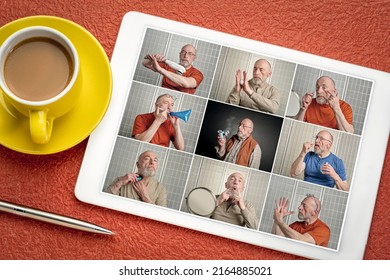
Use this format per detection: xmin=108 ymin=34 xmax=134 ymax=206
xmin=4 ymin=37 xmax=74 ymax=101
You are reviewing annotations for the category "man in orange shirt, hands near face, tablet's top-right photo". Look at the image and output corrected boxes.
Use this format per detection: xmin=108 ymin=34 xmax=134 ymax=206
xmin=295 ymin=76 xmax=354 ymax=133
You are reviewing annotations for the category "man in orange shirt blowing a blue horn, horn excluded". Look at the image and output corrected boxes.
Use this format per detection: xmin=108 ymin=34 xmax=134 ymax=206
xmin=131 ymin=94 xmax=184 ymax=150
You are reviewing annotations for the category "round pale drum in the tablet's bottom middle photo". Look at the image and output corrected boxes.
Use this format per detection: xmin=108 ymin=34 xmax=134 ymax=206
xmin=186 ymin=187 xmax=217 ymax=217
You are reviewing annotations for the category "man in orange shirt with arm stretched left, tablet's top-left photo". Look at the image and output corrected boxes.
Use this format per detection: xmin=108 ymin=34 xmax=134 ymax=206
xmin=142 ymin=44 xmax=203 ymax=94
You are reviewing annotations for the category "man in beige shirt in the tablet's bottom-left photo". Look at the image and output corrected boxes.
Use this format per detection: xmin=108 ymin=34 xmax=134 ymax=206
xmin=107 ymin=151 xmax=167 ymax=207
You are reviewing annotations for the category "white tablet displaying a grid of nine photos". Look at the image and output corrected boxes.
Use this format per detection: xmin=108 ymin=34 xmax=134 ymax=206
xmin=75 ymin=12 xmax=390 ymax=259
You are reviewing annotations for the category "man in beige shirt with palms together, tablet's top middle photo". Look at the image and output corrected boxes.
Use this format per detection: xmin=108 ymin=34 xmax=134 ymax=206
xmin=226 ymin=59 xmax=280 ymax=114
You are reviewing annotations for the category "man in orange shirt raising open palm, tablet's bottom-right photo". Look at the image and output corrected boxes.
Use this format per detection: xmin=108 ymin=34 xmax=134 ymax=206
xmin=272 ymin=194 xmax=330 ymax=247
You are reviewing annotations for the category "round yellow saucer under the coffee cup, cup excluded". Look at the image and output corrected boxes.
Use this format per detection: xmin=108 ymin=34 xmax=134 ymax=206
xmin=0 ymin=16 xmax=112 ymax=154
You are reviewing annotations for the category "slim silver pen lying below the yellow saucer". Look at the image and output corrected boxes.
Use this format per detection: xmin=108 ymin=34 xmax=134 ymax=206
xmin=0 ymin=200 xmax=114 ymax=235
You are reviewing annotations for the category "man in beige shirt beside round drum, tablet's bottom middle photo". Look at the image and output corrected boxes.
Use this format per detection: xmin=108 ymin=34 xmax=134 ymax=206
xmin=210 ymin=172 xmax=258 ymax=229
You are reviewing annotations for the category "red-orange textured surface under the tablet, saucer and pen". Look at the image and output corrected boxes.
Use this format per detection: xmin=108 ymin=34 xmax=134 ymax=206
xmin=0 ymin=0 xmax=390 ymax=259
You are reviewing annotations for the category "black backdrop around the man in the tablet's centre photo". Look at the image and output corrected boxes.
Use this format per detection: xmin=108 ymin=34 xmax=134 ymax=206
xmin=195 ymin=100 xmax=283 ymax=172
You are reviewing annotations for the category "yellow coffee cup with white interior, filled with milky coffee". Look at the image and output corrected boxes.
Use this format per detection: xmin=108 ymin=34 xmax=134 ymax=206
xmin=0 ymin=26 xmax=81 ymax=144
